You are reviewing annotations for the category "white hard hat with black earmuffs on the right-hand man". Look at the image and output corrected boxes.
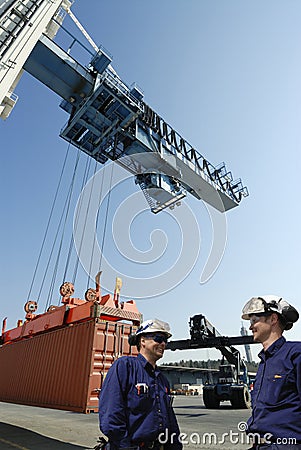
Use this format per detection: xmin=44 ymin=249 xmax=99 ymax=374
xmin=241 ymin=295 xmax=299 ymax=330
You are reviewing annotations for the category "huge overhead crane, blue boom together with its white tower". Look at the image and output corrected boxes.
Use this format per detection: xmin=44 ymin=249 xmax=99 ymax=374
xmin=0 ymin=0 xmax=248 ymax=213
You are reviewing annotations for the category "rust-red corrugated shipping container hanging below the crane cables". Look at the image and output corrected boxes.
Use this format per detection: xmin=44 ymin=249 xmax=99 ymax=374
xmin=0 ymin=319 xmax=136 ymax=412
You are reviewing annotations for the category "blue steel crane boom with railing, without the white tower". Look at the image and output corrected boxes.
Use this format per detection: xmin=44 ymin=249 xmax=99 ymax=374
xmin=24 ymin=30 xmax=248 ymax=212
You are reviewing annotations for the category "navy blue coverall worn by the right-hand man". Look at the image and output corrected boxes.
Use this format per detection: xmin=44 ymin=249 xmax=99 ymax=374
xmin=248 ymin=336 xmax=301 ymax=449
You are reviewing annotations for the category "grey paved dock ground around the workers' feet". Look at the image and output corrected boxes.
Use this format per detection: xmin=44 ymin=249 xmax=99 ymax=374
xmin=0 ymin=396 xmax=250 ymax=450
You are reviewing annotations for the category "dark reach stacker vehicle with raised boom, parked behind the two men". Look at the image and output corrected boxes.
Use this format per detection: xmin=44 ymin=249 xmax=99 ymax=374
xmin=166 ymin=314 xmax=254 ymax=409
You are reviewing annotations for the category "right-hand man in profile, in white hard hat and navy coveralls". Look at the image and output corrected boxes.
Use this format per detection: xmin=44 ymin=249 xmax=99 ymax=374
xmin=242 ymin=295 xmax=301 ymax=450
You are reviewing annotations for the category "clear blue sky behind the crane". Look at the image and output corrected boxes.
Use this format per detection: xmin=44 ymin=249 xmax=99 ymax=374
xmin=0 ymin=0 xmax=301 ymax=361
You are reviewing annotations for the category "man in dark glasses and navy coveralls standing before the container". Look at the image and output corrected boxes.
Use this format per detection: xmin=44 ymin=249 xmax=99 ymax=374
xmin=99 ymin=319 xmax=182 ymax=450
